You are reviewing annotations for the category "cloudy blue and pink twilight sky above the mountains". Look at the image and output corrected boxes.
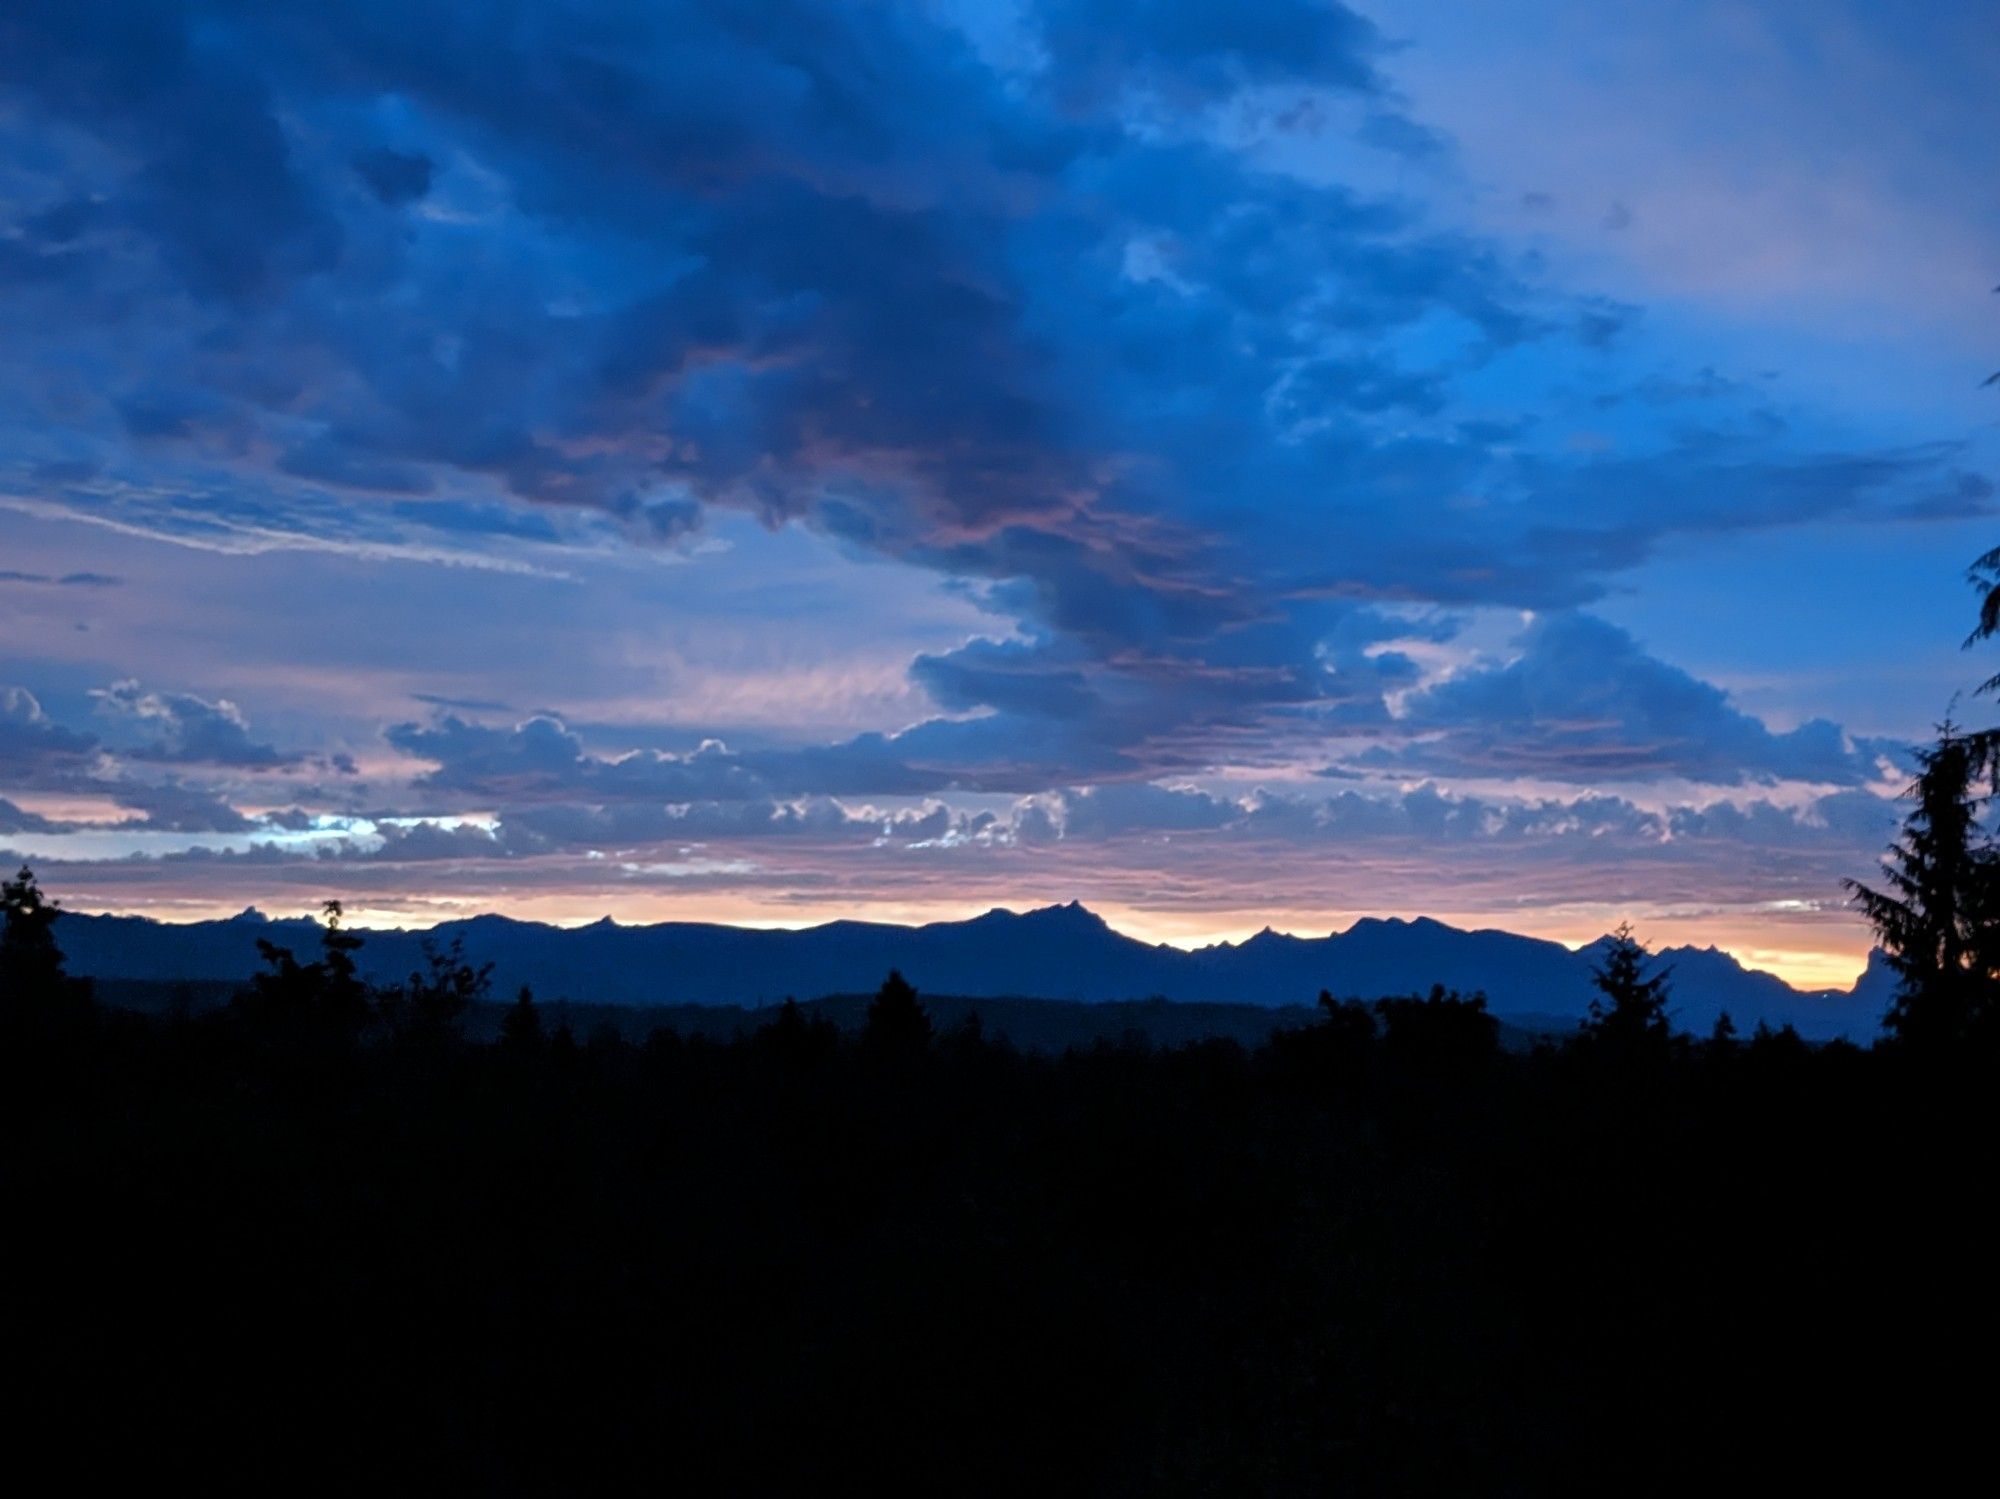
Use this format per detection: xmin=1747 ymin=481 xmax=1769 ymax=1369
xmin=0 ymin=0 xmax=2000 ymax=985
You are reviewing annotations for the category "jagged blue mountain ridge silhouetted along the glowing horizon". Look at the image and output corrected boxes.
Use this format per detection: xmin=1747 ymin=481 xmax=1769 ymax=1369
xmin=56 ymin=901 xmax=1894 ymax=1039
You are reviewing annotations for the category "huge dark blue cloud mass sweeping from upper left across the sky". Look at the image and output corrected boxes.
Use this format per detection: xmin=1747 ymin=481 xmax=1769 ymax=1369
xmin=0 ymin=0 xmax=1990 ymax=823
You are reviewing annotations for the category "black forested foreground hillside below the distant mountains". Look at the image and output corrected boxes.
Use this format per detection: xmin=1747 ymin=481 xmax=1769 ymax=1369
xmin=0 ymin=979 xmax=1996 ymax=1495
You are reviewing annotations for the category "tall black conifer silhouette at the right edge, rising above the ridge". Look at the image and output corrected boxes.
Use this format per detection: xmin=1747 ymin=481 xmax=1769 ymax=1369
xmin=1844 ymin=722 xmax=2000 ymax=1047
